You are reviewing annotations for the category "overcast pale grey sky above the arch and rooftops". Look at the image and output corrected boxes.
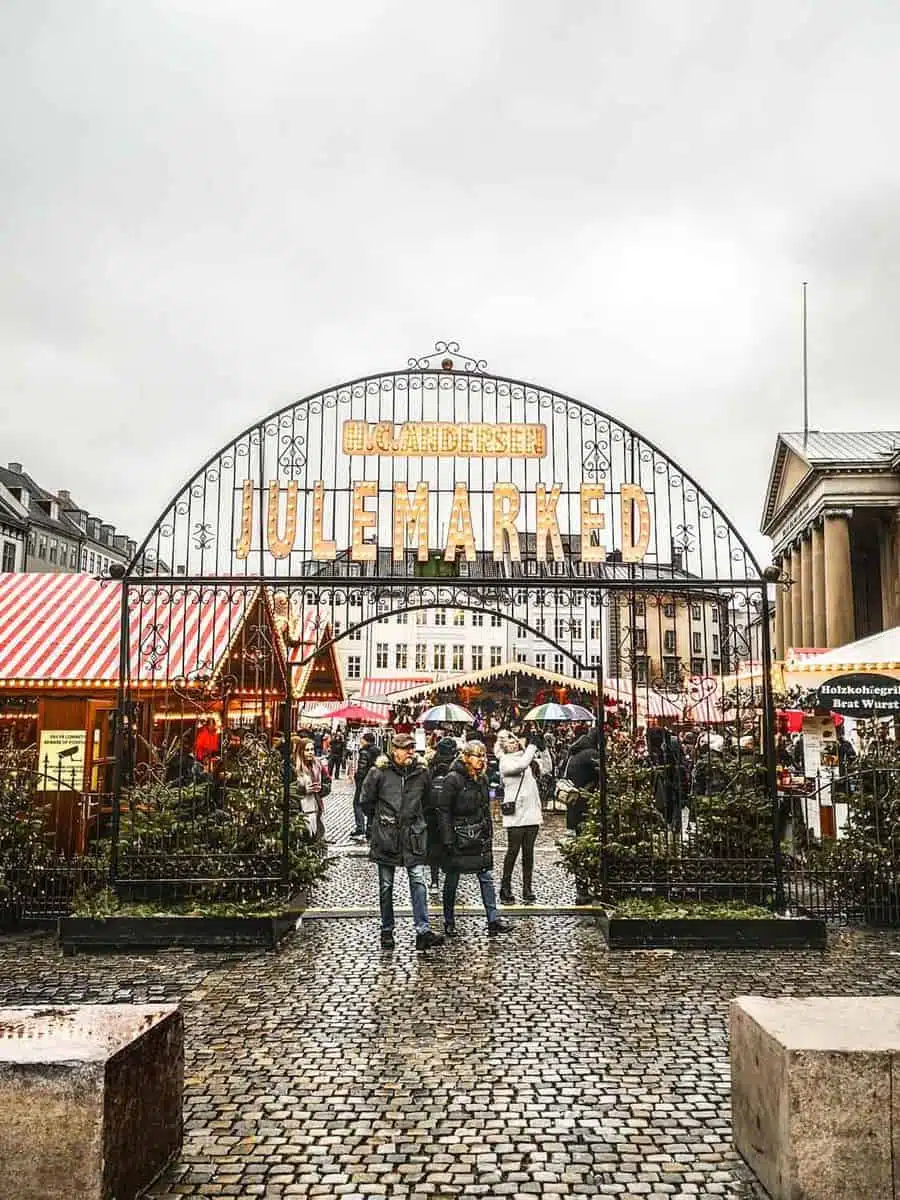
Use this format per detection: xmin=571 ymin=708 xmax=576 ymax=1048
xmin=0 ymin=0 xmax=900 ymax=564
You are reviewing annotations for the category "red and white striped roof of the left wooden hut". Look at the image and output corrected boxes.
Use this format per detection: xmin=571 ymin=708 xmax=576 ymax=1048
xmin=0 ymin=574 xmax=259 ymax=684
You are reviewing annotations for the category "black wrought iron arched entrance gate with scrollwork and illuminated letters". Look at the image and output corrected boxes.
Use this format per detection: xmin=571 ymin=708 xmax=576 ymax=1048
xmin=112 ymin=342 xmax=776 ymax=892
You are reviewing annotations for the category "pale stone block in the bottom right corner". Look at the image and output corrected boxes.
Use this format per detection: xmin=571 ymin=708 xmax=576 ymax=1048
xmin=731 ymin=996 xmax=900 ymax=1200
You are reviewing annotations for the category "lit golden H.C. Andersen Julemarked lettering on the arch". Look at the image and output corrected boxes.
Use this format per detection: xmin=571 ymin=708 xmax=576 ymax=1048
xmin=235 ymin=421 xmax=650 ymax=563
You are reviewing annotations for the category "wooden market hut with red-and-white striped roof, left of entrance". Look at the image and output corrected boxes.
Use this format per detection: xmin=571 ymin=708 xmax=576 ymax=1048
xmin=0 ymin=574 xmax=287 ymax=852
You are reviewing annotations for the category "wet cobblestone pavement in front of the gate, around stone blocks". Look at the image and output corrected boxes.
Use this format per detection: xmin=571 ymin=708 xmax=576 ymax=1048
xmin=0 ymin=782 xmax=900 ymax=1200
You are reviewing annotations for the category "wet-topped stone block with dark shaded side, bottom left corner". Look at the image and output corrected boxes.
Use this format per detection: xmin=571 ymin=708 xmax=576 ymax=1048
xmin=0 ymin=1004 xmax=184 ymax=1200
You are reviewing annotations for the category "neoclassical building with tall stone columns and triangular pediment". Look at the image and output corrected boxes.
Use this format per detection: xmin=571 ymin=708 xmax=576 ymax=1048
xmin=761 ymin=430 xmax=900 ymax=659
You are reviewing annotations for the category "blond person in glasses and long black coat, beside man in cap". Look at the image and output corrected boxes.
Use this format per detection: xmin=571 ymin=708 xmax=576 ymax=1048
xmin=437 ymin=742 xmax=512 ymax=937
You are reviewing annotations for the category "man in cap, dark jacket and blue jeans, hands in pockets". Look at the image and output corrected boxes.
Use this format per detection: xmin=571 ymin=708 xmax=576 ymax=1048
xmin=361 ymin=733 xmax=444 ymax=950
